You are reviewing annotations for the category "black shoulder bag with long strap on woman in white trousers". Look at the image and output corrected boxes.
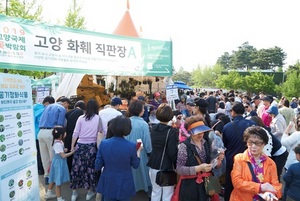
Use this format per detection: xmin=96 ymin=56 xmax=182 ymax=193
xmin=155 ymin=128 xmax=177 ymax=186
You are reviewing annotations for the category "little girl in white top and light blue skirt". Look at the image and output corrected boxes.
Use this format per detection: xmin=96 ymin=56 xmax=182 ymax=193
xmin=45 ymin=127 xmax=74 ymax=201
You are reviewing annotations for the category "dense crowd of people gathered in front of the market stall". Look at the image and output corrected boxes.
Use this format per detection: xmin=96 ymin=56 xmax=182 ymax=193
xmin=34 ymin=90 xmax=300 ymax=201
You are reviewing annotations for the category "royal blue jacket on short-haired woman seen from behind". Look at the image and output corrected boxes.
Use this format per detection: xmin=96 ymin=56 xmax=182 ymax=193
xmin=95 ymin=137 xmax=140 ymax=200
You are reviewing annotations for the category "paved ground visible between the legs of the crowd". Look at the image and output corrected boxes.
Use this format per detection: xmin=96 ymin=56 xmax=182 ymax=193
xmin=39 ymin=176 xmax=148 ymax=201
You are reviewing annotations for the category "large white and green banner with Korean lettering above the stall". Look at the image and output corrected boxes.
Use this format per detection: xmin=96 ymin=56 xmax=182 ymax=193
xmin=0 ymin=15 xmax=172 ymax=76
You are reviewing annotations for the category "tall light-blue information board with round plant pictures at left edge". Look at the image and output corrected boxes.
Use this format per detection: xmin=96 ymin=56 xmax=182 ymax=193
xmin=0 ymin=73 xmax=40 ymax=201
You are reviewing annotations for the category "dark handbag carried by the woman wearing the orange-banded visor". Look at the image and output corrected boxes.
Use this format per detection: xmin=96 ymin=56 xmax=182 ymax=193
xmin=194 ymin=148 xmax=222 ymax=196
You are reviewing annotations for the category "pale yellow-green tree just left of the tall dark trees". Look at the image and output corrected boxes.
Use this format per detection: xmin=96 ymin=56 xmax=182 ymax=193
xmin=192 ymin=64 xmax=223 ymax=88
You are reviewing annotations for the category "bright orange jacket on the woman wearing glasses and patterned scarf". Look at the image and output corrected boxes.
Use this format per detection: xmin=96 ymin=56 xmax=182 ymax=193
xmin=230 ymin=150 xmax=282 ymax=201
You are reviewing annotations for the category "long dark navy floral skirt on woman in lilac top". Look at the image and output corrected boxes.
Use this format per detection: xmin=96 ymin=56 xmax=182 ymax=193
xmin=70 ymin=143 xmax=98 ymax=191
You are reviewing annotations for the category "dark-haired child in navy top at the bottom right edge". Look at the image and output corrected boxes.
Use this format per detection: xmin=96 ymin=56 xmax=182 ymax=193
xmin=283 ymin=144 xmax=300 ymax=201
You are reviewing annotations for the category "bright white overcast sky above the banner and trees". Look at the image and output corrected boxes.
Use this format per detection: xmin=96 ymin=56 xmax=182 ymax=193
xmin=39 ymin=0 xmax=300 ymax=71
